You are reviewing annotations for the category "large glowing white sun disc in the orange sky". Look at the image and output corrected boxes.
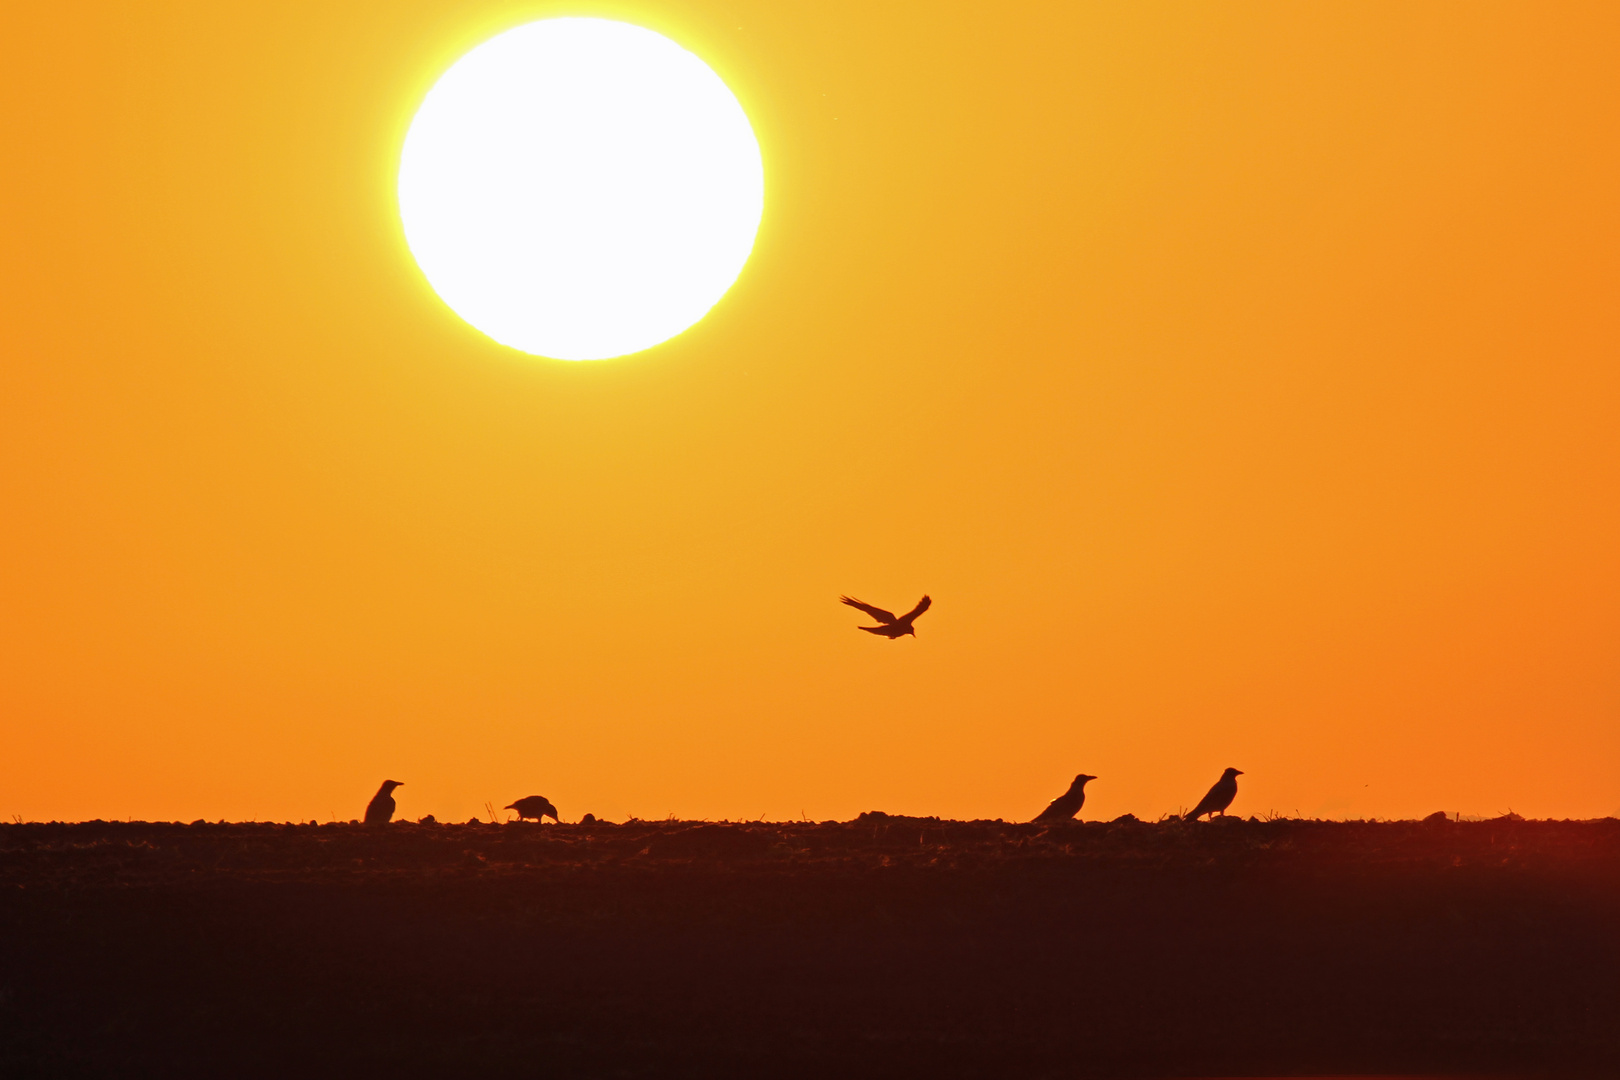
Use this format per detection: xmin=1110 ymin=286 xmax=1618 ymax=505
xmin=399 ymin=18 xmax=765 ymax=359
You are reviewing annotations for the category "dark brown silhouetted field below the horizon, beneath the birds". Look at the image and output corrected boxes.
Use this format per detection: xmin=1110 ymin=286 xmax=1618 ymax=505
xmin=0 ymin=816 xmax=1620 ymax=1080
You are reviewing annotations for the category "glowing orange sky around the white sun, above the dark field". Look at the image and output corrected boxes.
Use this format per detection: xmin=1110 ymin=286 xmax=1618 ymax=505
xmin=0 ymin=0 xmax=1620 ymax=819
